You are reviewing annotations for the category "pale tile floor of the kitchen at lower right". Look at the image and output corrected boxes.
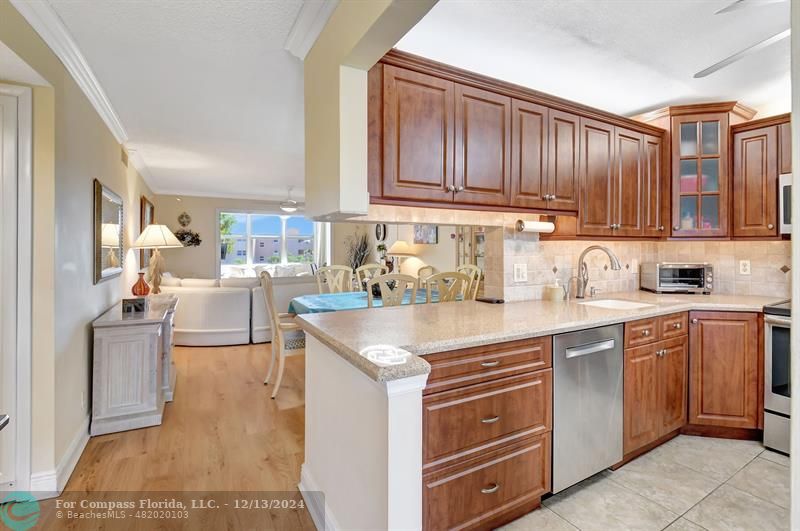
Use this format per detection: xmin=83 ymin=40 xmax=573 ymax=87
xmin=503 ymin=435 xmax=789 ymax=531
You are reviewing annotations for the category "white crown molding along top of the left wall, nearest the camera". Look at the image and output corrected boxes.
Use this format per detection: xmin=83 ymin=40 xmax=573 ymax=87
xmin=11 ymin=0 xmax=128 ymax=143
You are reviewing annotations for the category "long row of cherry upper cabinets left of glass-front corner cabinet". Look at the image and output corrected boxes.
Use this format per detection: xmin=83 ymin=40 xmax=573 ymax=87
xmin=367 ymin=51 xmax=664 ymax=220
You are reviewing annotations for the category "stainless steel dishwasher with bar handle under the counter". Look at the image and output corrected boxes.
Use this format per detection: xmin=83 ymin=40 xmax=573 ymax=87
xmin=553 ymin=324 xmax=623 ymax=493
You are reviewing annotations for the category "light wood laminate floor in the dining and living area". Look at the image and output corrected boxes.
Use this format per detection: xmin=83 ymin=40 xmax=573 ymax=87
xmin=42 ymin=344 xmax=313 ymax=529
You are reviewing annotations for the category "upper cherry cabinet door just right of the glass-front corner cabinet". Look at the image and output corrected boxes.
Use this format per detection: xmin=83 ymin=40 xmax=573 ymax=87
xmin=733 ymin=126 xmax=778 ymax=237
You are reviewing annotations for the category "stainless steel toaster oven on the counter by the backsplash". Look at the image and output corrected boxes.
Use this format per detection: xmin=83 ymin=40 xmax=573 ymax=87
xmin=639 ymin=262 xmax=714 ymax=293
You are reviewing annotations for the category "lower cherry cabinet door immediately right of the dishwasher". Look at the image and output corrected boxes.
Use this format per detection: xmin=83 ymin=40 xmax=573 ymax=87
xmin=622 ymin=345 xmax=661 ymax=454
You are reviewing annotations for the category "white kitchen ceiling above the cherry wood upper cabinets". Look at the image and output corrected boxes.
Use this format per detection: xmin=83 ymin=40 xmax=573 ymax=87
xmin=397 ymin=0 xmax=791 ymax=116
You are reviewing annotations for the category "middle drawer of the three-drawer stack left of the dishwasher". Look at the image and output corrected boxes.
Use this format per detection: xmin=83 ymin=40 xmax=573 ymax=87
xmin=422 ymin=369 xmax=553 ymax=466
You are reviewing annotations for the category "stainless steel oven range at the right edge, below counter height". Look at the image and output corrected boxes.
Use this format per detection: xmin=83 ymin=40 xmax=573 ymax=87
xmin=764 ymin=301 xmax=792 ymax=454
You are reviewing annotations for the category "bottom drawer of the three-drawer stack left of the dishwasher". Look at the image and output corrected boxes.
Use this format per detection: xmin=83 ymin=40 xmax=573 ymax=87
xmin=423 ymin=433 xmax=550 ymax=530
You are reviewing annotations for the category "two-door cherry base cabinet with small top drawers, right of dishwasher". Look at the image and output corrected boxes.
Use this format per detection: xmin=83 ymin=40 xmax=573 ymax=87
xmin=623 ymin=313 xmax=689 ymax=456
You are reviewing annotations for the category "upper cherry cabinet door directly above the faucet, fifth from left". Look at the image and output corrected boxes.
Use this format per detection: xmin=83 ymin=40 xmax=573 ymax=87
xmin=577 ymin=118 xmax=615 ymax=236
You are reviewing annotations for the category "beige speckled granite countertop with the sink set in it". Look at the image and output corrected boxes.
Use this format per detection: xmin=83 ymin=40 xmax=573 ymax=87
xmin=296 ymin=291 xmax=783 ymax=382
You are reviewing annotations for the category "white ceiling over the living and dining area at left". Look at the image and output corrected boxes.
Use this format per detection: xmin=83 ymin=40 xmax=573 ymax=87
xmin=48 ymin=0 xmax=304 ymax=199
